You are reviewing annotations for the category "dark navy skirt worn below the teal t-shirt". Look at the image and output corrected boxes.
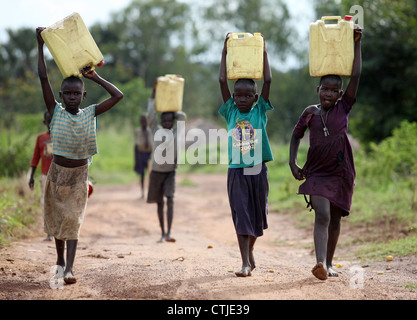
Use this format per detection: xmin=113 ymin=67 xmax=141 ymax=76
xmin=227 ymin=163 xmax=269 ymax=237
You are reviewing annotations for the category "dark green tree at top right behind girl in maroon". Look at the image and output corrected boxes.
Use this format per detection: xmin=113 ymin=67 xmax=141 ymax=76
xmin=316 ymin=0 xmax=417 ymax=143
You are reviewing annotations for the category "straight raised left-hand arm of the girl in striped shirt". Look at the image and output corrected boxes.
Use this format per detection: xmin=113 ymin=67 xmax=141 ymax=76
xmin=36 ymin=28 xmax=57 ymax=117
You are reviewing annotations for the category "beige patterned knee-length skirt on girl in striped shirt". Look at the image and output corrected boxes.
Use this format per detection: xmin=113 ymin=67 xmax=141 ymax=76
xmin=44 ymin=162 xmax=88 ymax=240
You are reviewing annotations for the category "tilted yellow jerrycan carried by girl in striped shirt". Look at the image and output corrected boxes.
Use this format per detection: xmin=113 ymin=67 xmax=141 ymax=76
xmin=41 ymin=12 xmax=104 ymax=78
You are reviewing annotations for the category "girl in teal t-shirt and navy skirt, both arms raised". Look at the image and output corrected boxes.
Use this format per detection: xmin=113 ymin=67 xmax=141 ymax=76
xmin=219 ymin=33 xmax=273 ymax=277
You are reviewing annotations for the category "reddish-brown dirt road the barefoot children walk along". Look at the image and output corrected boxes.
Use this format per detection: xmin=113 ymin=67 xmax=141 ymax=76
xmin=0 ymin=175 xmax=417 ymax=300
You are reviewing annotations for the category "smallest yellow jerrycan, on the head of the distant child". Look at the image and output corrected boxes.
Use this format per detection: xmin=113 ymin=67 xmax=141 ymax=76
xmin=155 ymin=74 xmax=184 ymax=112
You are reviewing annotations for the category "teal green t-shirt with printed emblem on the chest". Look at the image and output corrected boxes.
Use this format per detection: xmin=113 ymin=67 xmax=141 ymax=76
xmin=219 ymin=95 xmax=274 ymax=168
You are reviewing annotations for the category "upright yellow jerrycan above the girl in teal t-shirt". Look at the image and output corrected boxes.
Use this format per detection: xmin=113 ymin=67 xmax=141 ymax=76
xmin=226 ymin=33 xmax=264 ymax=80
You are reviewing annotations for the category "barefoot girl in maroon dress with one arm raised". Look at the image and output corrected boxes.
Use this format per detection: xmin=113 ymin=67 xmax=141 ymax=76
xmin=289 ymin=27 xmax=362 ymax=280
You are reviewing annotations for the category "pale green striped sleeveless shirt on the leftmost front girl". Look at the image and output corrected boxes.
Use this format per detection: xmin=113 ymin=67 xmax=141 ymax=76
xmin=51 ymin=103 xmax=98 ymax=159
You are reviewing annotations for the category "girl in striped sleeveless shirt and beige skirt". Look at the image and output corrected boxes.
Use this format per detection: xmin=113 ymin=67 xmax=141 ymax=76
xmin=36 ymin=28 xmax=123 ymax=284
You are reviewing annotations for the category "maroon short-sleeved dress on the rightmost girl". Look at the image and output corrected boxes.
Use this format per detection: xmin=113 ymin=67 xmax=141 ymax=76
xmin=293 ymin=95 xmax=356 ymax=216
